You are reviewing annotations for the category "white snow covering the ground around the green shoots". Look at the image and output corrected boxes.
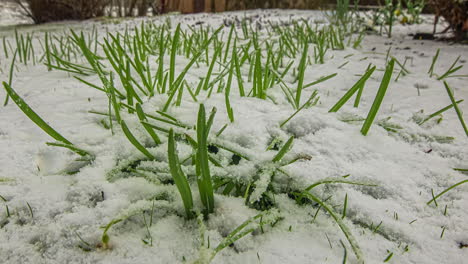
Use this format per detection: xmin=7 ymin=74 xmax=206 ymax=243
xmin=0 ymin=11 xmax=468 ymax=264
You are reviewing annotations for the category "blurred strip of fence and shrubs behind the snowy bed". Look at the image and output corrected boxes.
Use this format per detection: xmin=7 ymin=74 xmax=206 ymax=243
xmin=0 ymin=0 xmax=468 ymax=37
